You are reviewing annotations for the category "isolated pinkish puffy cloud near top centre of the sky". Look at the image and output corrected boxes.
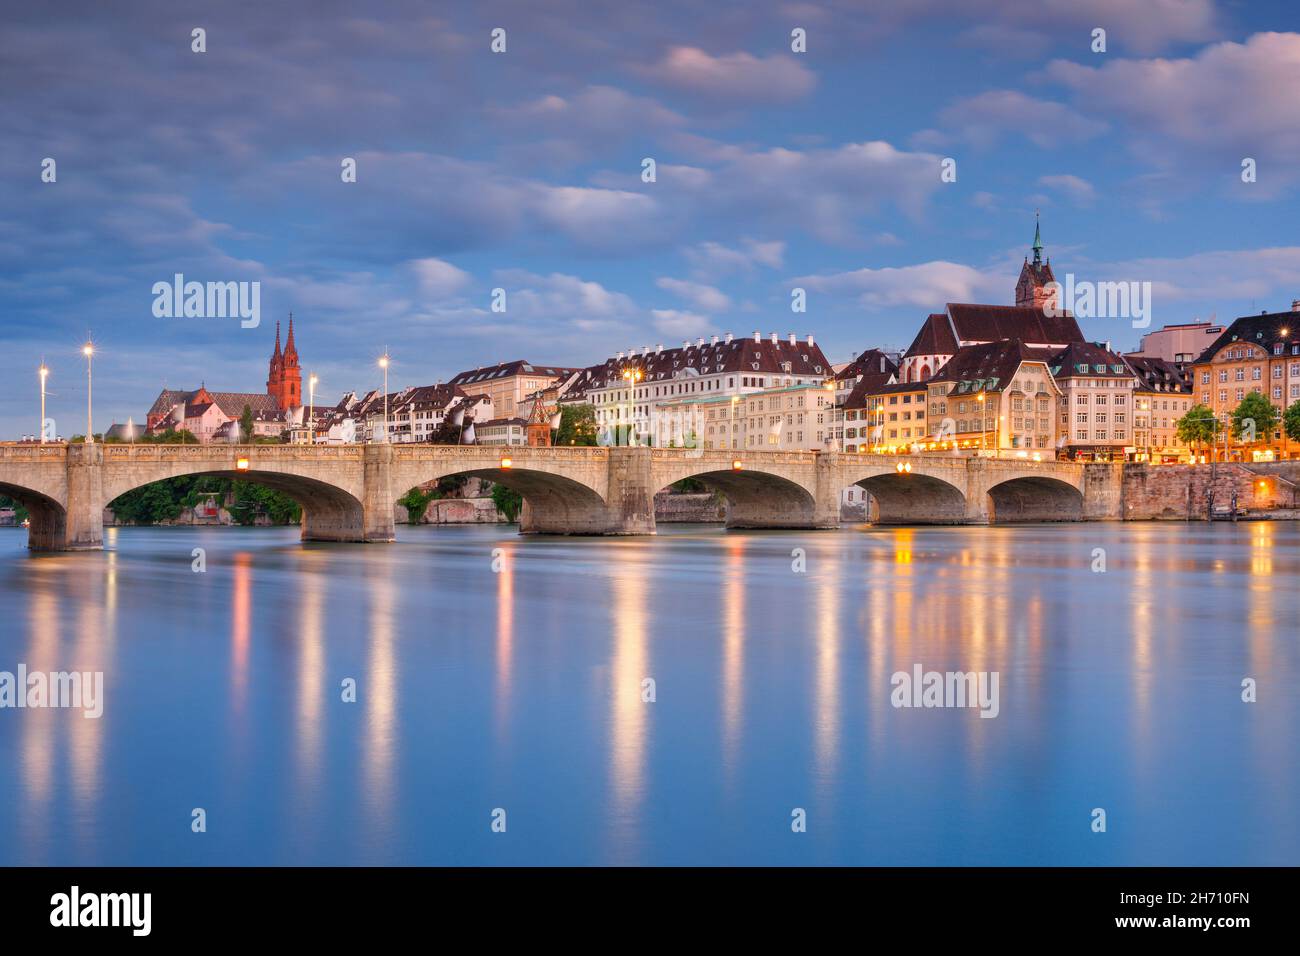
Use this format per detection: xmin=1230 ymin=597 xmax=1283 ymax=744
xmin=641 ymin=47 xmax=816 ymax=104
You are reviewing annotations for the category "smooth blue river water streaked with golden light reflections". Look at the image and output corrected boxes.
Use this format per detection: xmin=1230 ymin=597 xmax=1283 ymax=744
xmin=0 ymin=522 xmax=1300 ymax=865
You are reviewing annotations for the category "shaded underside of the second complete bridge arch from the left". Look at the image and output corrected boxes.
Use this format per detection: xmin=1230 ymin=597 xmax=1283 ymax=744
xmin=393 ymin=467 xmax=610 ymax=535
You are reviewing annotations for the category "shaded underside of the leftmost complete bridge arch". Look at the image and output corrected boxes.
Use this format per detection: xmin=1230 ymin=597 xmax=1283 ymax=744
xmin=105 ymin=470 xmax=377 ymax=541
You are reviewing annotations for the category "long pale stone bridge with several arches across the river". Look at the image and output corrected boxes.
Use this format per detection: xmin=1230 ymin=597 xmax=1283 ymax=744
xmin=0 ymin=445 xmax=1123 ymax=550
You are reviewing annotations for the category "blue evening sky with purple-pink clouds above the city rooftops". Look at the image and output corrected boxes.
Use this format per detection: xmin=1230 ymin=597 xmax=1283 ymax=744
xmin=0 ymin=0 xmax=1300 ymax=440
